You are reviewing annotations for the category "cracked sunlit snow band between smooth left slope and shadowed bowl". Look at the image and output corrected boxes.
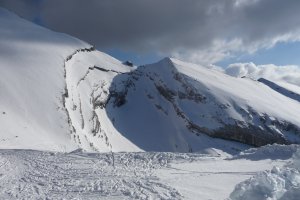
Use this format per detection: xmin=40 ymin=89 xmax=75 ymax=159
xmin=65 ymin=50 xmax=141 ymax=152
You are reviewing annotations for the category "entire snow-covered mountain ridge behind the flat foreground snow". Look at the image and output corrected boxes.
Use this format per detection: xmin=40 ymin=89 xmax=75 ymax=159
xmin=0 ymin=9 xmax=300 ymax=152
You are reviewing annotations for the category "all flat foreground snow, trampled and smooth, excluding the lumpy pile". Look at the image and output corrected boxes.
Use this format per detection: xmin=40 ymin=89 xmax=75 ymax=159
xmin=0 ymin=146 xmax=297 ymax=200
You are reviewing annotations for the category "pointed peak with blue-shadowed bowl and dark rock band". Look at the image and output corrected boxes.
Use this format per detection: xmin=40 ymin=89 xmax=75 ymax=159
xmin=107 ymin=58 xmax=300 ymax=151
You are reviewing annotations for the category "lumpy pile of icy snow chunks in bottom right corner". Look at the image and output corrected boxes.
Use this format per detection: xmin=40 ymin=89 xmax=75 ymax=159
xmin=230 ymin=146 xmax=300 ymax=200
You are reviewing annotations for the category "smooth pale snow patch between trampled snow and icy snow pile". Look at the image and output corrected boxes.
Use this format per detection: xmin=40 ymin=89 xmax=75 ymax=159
xmin=157 ymin=157 xmax=282 ymax=200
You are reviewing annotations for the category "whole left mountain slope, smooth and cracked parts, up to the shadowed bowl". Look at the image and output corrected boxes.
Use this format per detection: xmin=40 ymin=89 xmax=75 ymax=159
xmin=0 ymin=9 xmax=140 ymax=151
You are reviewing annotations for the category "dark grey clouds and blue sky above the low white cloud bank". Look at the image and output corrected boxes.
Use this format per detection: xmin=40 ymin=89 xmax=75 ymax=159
xmin=0 ymin=0 xmax=300 ymax=67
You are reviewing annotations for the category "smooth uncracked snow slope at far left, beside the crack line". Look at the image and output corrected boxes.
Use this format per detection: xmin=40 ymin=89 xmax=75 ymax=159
xmin=0 ymin=8 xmax=90 ymax=150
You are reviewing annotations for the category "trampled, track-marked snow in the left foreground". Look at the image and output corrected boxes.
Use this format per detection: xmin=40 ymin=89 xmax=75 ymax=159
xmin=0 ymin=150 xmax=197 ymax=199
